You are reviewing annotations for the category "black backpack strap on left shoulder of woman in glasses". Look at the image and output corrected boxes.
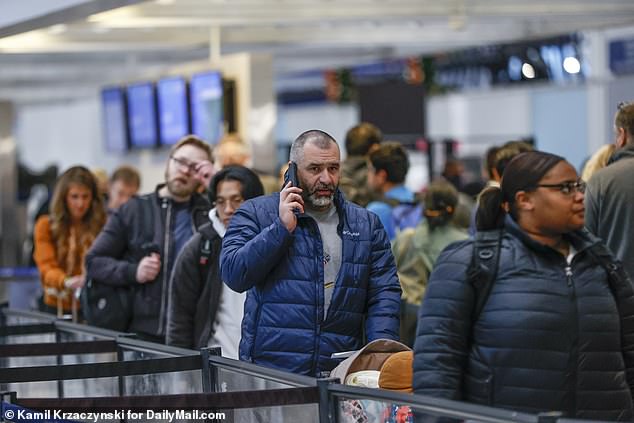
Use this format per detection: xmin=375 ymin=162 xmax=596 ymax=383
xmin=467 ymin=229 xmax=504 ymax=324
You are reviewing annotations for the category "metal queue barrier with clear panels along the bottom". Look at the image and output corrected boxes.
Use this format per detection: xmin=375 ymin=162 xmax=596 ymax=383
xmin=0 ymin=308 xmax=608 ymax=423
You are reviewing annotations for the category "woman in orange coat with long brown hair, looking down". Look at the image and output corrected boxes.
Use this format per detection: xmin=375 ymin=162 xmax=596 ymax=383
xmin=33 ymin=166 xmax=106 ymax=315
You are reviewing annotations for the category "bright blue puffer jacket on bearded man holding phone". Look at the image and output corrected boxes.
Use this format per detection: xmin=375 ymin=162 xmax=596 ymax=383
xmin=220 ymin=191 xmax=401 ymax=375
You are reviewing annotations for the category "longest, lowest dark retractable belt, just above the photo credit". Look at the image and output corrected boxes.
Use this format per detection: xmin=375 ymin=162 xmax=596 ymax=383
xmin=15 ymin=387 xmax=319 ymax=412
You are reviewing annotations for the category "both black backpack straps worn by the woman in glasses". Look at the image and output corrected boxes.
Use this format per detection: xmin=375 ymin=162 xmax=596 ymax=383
xmin=467 ymin=229 xmax=633 ymax=325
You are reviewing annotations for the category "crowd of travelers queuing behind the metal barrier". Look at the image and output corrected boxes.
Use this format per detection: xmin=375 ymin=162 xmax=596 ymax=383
xmin=33 ymin=103 xmax=634 ymax=421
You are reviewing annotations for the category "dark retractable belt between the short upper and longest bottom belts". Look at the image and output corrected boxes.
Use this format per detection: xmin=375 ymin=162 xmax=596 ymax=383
xmin=0 ymin=355 xmax=202 ymax=383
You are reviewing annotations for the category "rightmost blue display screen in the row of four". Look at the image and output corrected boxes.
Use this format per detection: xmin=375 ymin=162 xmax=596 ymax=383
xmin=189 ymin=72 xmax=223 ymax=144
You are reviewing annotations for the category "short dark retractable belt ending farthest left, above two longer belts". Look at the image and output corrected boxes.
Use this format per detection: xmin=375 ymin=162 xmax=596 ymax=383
xmin=0 ymin=340 xmax=117 ymax=357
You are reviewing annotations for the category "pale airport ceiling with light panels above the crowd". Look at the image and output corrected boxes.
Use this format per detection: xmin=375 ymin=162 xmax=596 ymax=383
xmin=0 ymin=0 xmax=634 ymax=102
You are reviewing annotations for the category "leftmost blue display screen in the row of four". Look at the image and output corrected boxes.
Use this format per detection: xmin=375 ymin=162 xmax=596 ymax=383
xmin=101 ymin=87 xmax=128 ymax=153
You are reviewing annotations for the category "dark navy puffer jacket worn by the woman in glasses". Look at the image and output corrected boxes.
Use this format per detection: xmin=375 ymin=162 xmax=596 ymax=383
xmin=414 ymin=216 xmax=634 ymax=421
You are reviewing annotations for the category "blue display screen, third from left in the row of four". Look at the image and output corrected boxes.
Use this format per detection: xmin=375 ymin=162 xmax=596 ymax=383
xmin=156 ymin=77 xmax=189 ymax=145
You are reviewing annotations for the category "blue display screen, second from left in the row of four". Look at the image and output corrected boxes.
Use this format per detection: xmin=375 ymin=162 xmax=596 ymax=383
xmin=127 ymin=82 xmax=158 ymax=147
